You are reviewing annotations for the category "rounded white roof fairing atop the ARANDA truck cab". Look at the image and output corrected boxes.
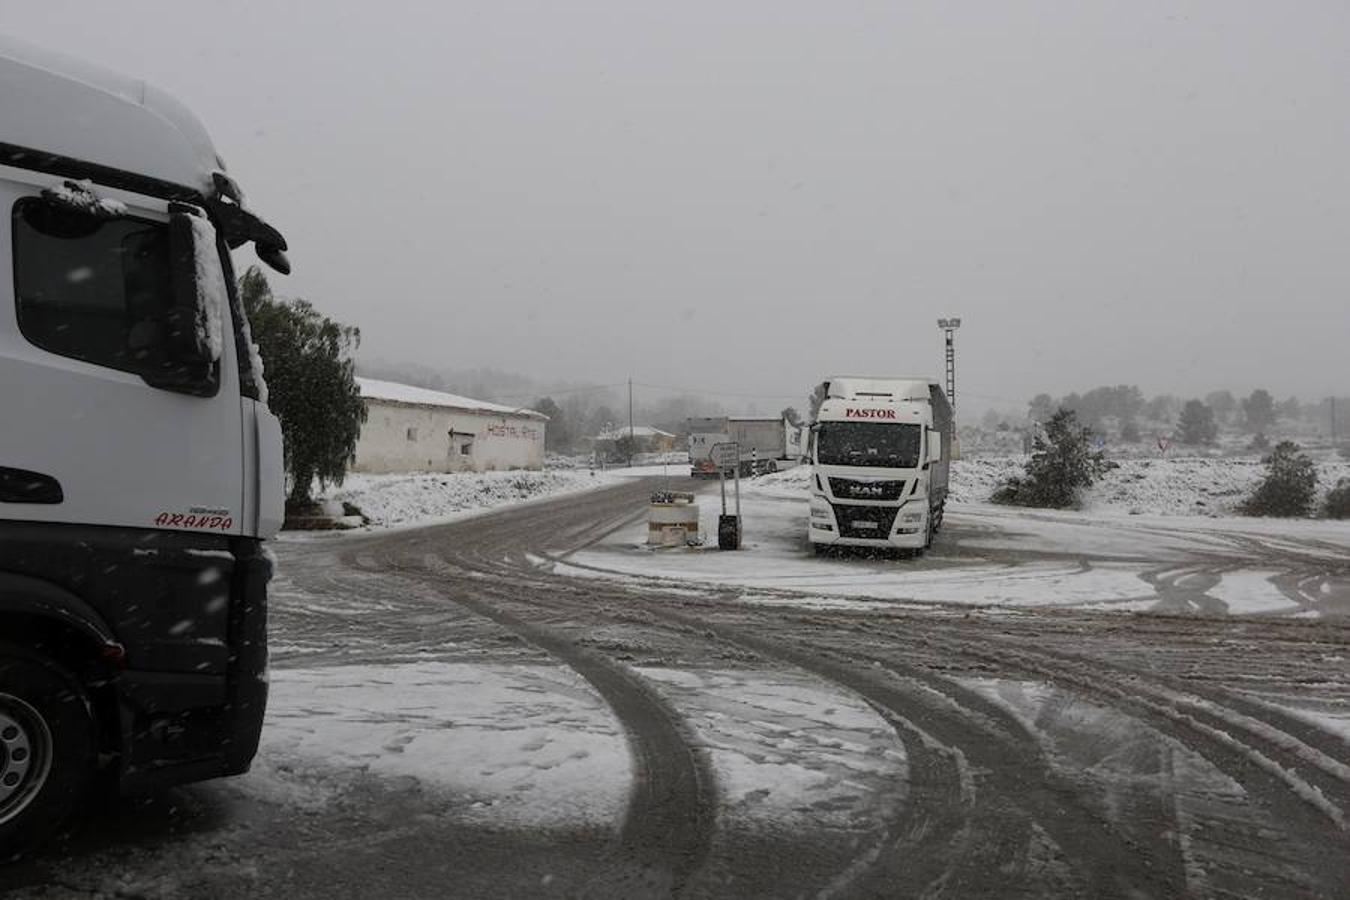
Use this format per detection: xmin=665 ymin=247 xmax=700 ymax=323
xmin=0 ymin=35 xmax=224 ymax=194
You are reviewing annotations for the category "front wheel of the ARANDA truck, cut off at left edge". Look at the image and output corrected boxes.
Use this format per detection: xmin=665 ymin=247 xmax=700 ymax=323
xmin=0 ymin=644 xmax=95 ymax=862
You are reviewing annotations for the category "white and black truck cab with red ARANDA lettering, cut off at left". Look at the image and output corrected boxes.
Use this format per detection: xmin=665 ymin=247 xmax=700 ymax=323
xmin=0 ymin=38 xmax=289 ymax=860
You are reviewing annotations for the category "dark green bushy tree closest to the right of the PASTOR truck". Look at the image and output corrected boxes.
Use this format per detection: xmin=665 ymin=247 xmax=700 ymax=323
xmin=992 ymin=409 xmax=1107 ymax=509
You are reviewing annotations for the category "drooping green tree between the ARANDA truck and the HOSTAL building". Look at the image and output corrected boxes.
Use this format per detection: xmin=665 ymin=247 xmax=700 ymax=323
xmin=239 ymin=266 xmax=366 ymax=509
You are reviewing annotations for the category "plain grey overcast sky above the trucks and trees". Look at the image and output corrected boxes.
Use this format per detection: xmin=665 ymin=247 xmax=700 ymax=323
xmin=0 ymin=0 xmax=1350 ymax=405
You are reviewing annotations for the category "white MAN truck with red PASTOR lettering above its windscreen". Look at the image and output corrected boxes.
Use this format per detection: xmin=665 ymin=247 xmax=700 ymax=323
xmin=807 ymin=376 xmax=954 ymax=553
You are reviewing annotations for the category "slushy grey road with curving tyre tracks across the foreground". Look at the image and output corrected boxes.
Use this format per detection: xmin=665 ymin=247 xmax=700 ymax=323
xmin=3 ymin=480 xmax=1350 ymax=897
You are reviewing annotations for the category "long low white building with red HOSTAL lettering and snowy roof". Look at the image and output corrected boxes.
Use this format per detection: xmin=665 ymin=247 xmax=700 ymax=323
xmin=352 ymin=378 xmax=548 ymax=472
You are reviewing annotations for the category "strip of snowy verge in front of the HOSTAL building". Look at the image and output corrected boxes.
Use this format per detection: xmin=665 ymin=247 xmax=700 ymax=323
xmin=320 ymin=470 xmax=612 ymax=528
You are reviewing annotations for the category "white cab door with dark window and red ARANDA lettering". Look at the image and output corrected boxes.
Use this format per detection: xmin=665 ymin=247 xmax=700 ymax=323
xmin=0 ymin=167 xmax=244 ymax=534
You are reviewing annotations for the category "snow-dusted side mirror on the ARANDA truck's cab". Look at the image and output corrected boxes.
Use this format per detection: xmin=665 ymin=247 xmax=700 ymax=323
xmin=142 ymin=202 xmax=228 ymax=397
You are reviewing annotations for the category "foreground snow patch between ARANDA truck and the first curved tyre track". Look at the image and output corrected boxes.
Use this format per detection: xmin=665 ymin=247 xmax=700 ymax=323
xmin=240 ymin=663 xmax=632 ymax=827
